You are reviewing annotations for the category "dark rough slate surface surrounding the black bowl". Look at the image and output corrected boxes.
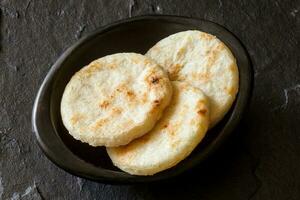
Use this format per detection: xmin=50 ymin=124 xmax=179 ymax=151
xmin=0 ymin=0 xmax=300 ymax=200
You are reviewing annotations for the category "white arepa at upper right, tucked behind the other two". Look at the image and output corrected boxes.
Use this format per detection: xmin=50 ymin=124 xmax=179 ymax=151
xmin=146 ymin=31 xmax=239 ymax=127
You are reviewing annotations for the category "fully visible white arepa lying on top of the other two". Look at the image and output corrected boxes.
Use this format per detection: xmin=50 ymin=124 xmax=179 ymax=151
xmin=61 ymin=53 xmax=172 ymax=146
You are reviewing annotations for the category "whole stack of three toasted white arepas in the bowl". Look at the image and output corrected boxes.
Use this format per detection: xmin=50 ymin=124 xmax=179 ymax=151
xmin=61 ymin=31 xmax=239 ymax=175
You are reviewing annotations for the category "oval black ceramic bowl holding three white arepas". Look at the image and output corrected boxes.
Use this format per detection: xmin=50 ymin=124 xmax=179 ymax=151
xmin=32 ymin=16 xmax=252 ymax=183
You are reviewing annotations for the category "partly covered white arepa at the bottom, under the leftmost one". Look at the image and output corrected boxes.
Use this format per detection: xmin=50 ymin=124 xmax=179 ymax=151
xmin=107 ymin=81 xmax=209 ymax=175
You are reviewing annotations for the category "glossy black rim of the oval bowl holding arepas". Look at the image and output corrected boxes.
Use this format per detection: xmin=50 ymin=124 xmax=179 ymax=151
xmin=31 ymin=15 xmax=253 ymax=184
